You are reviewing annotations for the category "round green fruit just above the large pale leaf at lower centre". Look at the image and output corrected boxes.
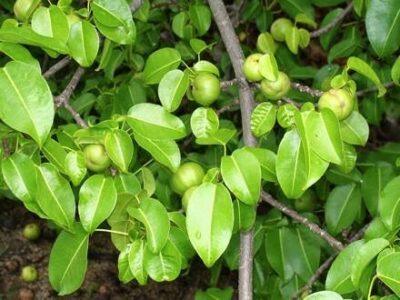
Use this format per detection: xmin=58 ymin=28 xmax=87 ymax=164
xmin=171 ymin=162 xmax=205 ymax=195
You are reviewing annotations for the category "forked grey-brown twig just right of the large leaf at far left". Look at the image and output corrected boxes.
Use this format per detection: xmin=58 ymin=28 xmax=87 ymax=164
xmin=54 ymin=67 xmax=88 ymax=128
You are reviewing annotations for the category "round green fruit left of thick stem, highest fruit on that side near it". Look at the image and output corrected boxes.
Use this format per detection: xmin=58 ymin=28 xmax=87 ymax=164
xmin=192 ymin=72 xmax=221 ymax=106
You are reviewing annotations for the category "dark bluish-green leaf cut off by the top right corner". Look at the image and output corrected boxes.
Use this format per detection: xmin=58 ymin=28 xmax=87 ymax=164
xmin=365 ymin=0 xmax=400 ymax=57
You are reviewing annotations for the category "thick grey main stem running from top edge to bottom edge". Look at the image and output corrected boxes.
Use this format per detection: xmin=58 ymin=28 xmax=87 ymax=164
xmin=208 ymin=0 xmax=257 ymax=300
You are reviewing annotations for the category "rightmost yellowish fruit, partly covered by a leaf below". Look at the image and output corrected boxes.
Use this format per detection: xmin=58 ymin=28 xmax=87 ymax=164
xmin=318 ymin=89 xmax=355 ymax=121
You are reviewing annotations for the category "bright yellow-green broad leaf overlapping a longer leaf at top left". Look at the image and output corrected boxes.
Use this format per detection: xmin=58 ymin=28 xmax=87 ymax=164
xmin=31 ymin=5 xmax=69 ymax=43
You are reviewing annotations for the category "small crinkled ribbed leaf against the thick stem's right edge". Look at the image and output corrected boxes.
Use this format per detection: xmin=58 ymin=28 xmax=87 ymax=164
xmin=250 ymin=102 xmax=277 ymax=137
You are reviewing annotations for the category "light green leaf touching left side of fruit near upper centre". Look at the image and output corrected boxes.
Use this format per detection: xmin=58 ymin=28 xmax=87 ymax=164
xmin=158 ymin=70 xmax=189 ymax=112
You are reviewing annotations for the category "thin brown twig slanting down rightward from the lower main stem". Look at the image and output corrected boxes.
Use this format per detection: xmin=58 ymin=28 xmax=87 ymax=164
xmin=261 ymin=192 xmax=344 ymax=251
